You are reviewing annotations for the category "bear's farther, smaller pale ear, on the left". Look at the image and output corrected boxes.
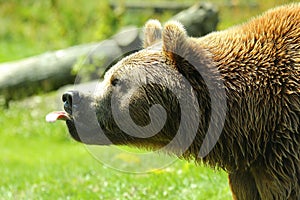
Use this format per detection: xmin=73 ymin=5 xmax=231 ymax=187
xmin=143 ymin=19 xmax=162 ymax=48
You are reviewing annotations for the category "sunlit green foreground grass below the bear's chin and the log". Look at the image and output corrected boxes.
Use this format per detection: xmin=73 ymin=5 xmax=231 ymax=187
xmin=0 ymin=93 xmax=231 ymax=199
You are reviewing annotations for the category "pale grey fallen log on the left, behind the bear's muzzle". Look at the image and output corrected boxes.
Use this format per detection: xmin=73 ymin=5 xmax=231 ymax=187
xmin=0 ymin=40 xmax=121 ymax=107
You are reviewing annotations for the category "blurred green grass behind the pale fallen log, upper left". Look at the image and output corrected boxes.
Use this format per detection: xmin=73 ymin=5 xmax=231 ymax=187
xmin=0 ymin=0 xmax=119 ymax=62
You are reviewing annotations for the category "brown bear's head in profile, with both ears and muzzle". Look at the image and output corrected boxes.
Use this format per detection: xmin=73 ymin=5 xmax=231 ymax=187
xmin=47 ymin=20 xmax=226 ymax=158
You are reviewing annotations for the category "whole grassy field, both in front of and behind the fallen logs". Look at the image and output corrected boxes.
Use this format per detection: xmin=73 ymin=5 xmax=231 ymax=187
xmin=0 ymin=0 xmax=296 ymax=200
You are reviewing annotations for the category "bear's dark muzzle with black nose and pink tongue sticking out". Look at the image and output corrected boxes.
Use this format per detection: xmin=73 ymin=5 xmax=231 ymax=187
xmin=46 ymin=91 xmax=112 ymax=145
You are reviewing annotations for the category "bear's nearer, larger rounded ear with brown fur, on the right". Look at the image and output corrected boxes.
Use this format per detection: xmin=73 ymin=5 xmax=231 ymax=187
xmin=162 ymin=21 xmax=187 ymax=61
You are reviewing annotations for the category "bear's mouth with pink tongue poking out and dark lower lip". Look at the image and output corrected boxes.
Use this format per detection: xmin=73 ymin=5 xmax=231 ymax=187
xmin=46 ymin=111 xmax=82 ymax=142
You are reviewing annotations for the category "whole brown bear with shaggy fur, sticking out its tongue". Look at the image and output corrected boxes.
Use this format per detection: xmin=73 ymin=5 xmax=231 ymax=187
xmin=48 ymin=3 xmax=300 ymax=200
